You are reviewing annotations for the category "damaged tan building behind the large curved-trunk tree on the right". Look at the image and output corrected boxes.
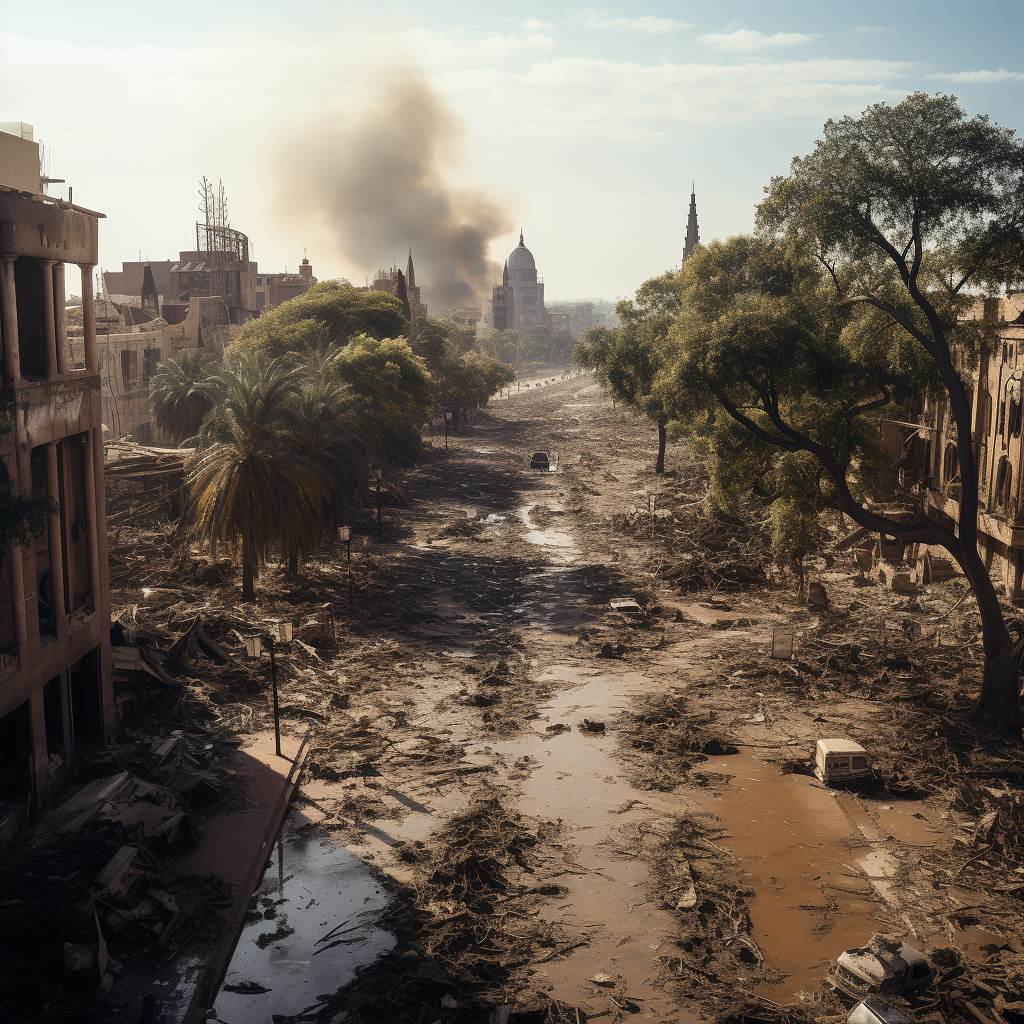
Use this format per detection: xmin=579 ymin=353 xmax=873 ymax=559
xmin=882 ymin=292 xmax=1024 ymax=601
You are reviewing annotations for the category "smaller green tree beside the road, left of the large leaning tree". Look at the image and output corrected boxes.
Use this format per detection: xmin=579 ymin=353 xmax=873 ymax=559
xmin=572 ymin=270 xmax=680 ymax=473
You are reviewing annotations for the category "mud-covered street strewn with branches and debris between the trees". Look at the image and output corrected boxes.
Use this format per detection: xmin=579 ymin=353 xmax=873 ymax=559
xmin=114 ymin=377 xmax=1024 ymax=1024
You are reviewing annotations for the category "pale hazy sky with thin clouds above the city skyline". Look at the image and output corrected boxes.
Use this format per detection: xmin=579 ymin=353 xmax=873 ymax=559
xmin=0 ymin=0 xmax=1024 ymax=302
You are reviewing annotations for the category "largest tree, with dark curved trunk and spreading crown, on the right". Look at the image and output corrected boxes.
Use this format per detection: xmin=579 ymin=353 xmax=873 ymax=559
xmin=672 ymin=93 xmax=1024 ymax=730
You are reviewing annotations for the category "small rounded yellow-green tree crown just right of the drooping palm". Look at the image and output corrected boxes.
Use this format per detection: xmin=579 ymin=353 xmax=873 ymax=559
xmin=336 ymin=335 xmax=433 ymax=458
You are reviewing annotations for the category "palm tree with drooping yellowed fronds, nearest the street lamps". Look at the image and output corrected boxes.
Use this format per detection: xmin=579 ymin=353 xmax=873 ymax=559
xmin=188 ymin=353 xmax=329 ymax=601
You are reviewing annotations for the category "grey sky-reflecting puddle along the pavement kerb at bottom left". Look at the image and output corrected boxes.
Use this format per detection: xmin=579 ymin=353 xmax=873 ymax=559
xmin=215 ymin=823 xmax=394 ymax=1024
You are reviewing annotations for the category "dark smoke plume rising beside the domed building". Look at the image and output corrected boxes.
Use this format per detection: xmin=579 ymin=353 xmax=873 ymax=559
xmin=280 ymin=76 xmax=513 ymax=313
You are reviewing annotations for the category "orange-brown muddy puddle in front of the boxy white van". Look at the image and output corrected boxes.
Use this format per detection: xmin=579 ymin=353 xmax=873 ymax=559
xmin=700 ymin=754 xmax=879 ymax=1001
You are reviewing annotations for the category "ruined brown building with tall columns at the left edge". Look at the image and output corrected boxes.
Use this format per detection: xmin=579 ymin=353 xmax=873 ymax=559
xmin=0 ymin=126 xmax=114 ymax=839
